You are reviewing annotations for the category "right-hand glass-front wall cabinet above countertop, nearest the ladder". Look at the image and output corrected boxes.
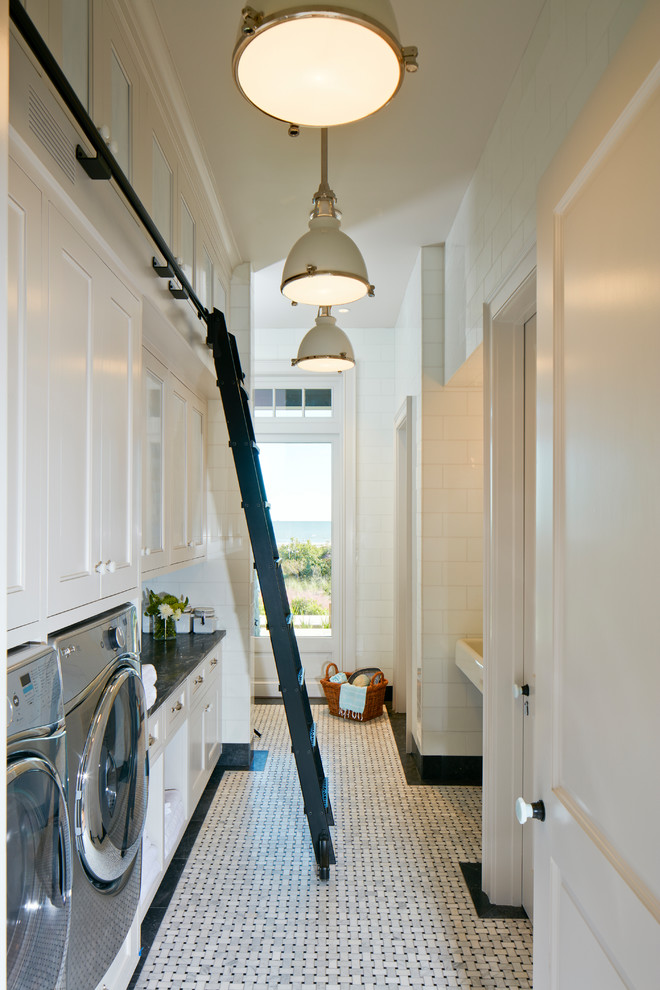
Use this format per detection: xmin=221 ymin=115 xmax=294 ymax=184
xmin=168 ymin=376 xmax=206 ymax=564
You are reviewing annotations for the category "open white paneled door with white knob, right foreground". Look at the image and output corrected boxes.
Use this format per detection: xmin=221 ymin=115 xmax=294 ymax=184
xmin=536 ymin=9 xmax=660 ymax=990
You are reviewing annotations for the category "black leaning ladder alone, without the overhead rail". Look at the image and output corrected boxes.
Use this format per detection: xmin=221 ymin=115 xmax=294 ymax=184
xmin=206 ymin=310 xmax=336 ymax=879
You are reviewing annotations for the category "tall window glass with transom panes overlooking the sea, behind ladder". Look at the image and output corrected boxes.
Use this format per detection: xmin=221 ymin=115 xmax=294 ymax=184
xmin=252 ymin=374 xmax=344 ymax=660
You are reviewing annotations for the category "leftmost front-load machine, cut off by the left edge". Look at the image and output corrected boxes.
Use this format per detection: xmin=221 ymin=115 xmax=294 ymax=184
xmin=7 ymin=643 xmax=71 ymax=990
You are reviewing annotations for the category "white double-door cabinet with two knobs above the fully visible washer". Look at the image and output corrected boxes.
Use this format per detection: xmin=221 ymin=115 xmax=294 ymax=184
xmin=47 ymin=205 xmax=140 ymax=615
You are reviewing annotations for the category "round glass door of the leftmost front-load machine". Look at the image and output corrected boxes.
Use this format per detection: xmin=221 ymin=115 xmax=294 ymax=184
xmin=7 ymin=756 xmax=71 ymax=990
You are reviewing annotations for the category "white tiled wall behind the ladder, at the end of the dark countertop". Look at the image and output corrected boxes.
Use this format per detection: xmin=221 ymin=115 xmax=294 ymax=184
xmin=144 ymin=265 xmax=254 ymax=746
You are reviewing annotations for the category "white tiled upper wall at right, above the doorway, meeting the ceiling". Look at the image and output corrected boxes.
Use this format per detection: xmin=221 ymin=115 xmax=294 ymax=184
xmin=445 ymin=0 xmax=644 ymax=381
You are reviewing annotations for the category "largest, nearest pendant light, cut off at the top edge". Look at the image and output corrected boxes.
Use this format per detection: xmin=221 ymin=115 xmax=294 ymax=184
xmin=233 ymin=0 xmax=417 ymax=127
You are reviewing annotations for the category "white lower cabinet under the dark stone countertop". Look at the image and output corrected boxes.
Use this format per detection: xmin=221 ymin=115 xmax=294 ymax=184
xmin=139 ymin=644 xmax=222 ymax=921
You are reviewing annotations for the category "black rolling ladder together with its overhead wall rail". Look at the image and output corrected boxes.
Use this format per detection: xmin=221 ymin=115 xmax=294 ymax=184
xmin=10 ymin=0 xmax=336 ymax=880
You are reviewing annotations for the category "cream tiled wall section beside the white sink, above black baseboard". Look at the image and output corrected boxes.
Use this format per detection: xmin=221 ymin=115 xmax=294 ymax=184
xmin=418 ymin=245 xmax=483 ymax=756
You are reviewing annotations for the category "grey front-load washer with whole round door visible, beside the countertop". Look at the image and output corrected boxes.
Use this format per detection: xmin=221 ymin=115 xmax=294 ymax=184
xmin=52 ymin=605 xmax=149 ymax=990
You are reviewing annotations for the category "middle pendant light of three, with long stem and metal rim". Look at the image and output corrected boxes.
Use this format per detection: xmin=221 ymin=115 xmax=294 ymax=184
xmin=280 ymin=128 xmax=374 ymax=306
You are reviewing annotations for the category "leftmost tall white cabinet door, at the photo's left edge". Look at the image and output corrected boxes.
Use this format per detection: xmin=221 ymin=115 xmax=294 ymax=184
xmin=7 ymin=159 xmax=47 ymax=629
